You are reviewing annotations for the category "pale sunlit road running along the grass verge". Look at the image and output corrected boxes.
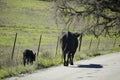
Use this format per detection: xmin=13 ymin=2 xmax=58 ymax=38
xmin=5 ymin=52 xmax=120 ymax=80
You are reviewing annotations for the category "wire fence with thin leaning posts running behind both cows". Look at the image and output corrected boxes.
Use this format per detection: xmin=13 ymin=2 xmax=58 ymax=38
xmin=0 ymin=33 xmax=120 ymax=67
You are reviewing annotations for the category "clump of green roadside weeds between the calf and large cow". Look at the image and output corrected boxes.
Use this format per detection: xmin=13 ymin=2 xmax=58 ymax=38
xmin=36 ymin=52 xmax=61 ymax=69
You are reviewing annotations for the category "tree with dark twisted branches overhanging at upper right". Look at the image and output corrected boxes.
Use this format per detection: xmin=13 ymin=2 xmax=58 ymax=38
xmin=55 ymin=0 xmax=120 ymax=37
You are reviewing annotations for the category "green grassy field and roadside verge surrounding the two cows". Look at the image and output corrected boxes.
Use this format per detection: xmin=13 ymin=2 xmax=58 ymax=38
xmin=0 ymin=0 xmax=120 ymax=79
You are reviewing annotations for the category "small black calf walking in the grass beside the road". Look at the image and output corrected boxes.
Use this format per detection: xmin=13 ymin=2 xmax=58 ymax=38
xmin=23 ymin=49 xmax=36 ymax=66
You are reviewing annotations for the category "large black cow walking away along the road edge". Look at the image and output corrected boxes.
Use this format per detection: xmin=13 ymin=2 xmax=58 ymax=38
xmin=60 ymin=32 xmax=80 ymax=66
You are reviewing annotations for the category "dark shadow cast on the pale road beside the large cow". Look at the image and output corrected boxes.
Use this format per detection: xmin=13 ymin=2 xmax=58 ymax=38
xmin=72 ymin=64 xmax=103 ymax=68
